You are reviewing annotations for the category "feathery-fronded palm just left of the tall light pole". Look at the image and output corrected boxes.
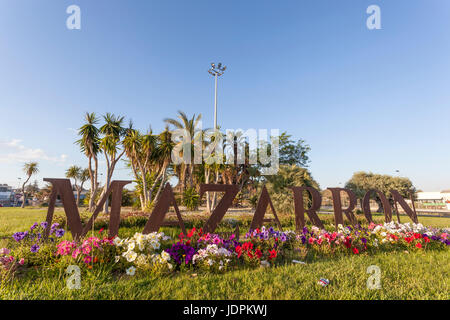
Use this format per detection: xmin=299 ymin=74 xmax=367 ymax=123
xmin=164 ymin=111 xmax=202 ymax=191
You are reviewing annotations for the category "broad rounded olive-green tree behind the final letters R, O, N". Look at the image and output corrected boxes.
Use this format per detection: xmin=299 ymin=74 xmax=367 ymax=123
xmin=345 ymin=171 xmax=416 ymax=212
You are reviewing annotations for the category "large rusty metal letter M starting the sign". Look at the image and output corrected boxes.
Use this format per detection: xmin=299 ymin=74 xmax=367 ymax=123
xmin=44 ymin=179 xmax=131 ymax=239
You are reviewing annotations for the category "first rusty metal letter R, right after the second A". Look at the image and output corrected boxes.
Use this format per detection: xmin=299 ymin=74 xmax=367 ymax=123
xmin=291 ymin=187 xmax=324 ymax=232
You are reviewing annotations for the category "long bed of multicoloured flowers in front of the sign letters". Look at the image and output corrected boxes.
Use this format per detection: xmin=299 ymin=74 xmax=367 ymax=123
xmin=0 ymin=222 xmax=450 ymax=276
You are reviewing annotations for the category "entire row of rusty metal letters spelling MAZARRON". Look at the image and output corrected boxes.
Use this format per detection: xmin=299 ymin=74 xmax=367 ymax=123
xmin=44 ymin=179 xmax=418 ymax=239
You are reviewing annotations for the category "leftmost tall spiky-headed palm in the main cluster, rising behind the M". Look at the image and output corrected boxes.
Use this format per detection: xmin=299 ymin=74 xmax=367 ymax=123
xmin=76 ymin=112 xmax=100 ymax=212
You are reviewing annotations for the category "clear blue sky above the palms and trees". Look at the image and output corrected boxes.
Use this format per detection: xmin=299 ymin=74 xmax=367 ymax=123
xmin=0 ymin=0 xmax=450 ymax=191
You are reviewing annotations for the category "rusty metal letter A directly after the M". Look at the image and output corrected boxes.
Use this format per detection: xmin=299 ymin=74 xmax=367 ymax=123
xmin=143 ymin=183 xmax=187 ymax=234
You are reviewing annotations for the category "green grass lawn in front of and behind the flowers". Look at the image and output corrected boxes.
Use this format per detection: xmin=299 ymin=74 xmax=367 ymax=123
xmin=0 ymin=208 xmax=450 ymax=300
